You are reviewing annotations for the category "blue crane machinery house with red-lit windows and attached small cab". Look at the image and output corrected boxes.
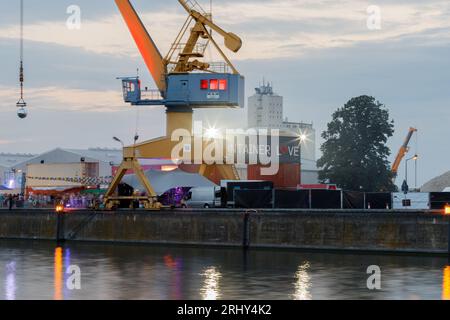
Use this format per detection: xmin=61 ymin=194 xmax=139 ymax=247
xmin=120 ymin=73 xmax=245 ymax=108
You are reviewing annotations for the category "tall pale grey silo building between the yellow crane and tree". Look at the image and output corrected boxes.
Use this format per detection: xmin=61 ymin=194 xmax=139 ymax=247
xmin=247 ymin=82 xmax=318 ymax=184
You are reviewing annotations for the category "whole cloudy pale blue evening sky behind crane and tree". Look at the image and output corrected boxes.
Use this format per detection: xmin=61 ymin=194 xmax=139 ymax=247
xmin=0 ymin=0 xmax=450 ymax=185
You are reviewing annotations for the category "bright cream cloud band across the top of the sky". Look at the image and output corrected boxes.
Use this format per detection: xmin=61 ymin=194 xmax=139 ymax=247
xmin=0 ymin=0 xmax=450 ymax=60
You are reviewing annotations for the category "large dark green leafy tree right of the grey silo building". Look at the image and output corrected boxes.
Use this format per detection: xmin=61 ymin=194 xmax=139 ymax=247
xmin=317 ymin=96 xmax=395 ymax=192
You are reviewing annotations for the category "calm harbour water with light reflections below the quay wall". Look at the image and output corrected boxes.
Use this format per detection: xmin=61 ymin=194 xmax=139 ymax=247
xmin=0 ymin=240 xmax=450 ymax=299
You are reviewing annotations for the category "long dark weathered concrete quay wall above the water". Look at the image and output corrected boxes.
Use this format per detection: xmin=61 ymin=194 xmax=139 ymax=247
xmin=0 ymin=209 xmax=450 ymax=254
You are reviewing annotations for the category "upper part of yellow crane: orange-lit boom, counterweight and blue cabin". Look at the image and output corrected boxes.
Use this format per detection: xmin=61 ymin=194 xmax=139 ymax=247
xmin=115 ymin=0 xmax=245 ymax=108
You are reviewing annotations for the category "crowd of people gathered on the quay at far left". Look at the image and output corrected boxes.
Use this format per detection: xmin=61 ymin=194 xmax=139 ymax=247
xmin=0 ymin=193 xmax=103 ymax=210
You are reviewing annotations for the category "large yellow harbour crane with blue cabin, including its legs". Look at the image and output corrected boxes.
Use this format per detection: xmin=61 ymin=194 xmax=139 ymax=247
xmin=105 ymin=0 xmax=244 ymax=209
